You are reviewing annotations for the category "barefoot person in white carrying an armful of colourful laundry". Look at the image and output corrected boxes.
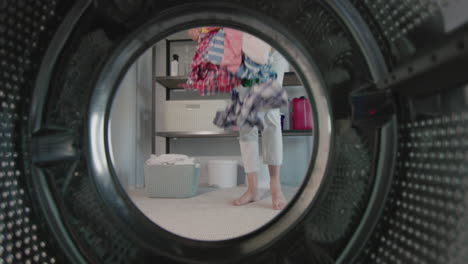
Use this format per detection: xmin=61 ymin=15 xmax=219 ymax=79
xmin=186 ymin=27 xmax=288 ymax=210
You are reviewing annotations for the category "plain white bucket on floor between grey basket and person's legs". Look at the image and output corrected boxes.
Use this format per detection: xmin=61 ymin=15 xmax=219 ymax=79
xmin=207 ymin=160 xmax=237 ymax=188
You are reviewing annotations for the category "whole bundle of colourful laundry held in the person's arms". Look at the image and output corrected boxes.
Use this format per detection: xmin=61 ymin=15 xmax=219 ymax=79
xmin=182 ymin=27 xmax=288 ymax=129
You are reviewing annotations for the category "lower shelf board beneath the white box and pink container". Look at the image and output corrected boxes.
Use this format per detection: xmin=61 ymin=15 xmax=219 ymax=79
xmin=155 ymin=130 xmax=312 ymax=138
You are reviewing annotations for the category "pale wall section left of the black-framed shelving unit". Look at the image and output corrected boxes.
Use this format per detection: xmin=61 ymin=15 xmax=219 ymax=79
xmin=110 ymin=50 xmax=152 ymax=188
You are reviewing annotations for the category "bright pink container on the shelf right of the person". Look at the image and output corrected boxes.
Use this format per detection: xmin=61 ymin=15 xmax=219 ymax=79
xmin=291 ymin=96 xmax=312 ymax=130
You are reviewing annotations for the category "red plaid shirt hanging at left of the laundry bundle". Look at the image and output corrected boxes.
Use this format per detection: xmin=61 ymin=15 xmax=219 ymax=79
xmin=182 ymin=31 xmax=241 ymax=95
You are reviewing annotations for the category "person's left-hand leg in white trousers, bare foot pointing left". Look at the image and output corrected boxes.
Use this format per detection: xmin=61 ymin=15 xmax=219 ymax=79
xmin=232 ymin=127 xmax=259 ymax=206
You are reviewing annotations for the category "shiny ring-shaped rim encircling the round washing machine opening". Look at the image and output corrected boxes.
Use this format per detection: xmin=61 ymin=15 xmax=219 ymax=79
xmin=88 ymin=3 xmax=332 ymax=260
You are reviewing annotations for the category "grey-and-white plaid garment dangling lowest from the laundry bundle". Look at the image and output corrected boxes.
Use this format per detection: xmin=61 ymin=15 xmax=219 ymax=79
xmin=213 ymin=80 xmax=288 ymax=130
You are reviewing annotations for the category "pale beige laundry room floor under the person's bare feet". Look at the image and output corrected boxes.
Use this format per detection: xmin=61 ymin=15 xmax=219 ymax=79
xmin=128 ymin=186 xmax=298 ymax=240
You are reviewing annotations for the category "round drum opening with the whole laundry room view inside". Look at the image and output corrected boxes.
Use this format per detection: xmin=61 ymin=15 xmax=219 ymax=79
xmin=108 ymin=26 xmax=319 ymax=241
